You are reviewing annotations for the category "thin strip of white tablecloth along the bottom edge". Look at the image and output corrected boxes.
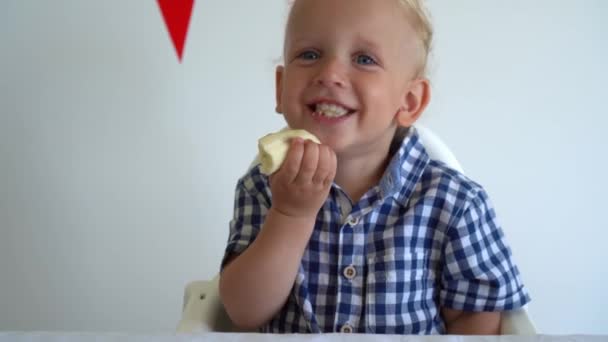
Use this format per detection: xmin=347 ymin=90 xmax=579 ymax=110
xmin=0 ymin=332 xmax=608 ymax=342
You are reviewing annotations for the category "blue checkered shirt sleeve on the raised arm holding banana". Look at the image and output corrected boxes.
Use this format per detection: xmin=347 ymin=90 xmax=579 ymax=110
xmin=221 ymin=175 xmax=270 ymax=270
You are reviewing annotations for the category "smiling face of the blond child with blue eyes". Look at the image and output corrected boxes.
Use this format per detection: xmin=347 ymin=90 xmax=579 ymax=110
xmin=277 ymin=0 xmax=420 ymax=156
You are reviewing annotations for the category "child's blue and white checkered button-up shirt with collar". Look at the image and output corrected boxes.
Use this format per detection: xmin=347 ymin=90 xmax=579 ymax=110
xmin=222 ymin=129 xmax=530 ymax=334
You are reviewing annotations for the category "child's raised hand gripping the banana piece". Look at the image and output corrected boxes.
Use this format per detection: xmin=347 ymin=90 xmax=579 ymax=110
xmin=270 ymin=138 xmax=337 ymax=218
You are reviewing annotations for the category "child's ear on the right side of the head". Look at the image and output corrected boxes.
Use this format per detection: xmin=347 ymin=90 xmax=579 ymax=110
xmin=397 ymin=78 xmax=431 ymax=127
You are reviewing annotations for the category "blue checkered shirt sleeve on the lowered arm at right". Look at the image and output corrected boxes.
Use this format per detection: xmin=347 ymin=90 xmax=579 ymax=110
xmin=440 ymin=190 xmax=530 ymax=312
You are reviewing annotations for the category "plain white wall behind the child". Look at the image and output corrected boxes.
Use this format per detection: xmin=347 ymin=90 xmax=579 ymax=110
xmin=0 ymin=0 xmax=608 ymax=334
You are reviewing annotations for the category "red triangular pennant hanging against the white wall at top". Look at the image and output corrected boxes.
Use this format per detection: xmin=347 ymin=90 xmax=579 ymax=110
xmin=157 ymin=0 xmax=194 ymax=62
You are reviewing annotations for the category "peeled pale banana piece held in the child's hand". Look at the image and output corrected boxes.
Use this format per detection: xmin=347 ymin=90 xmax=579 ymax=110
xmin=258 ymin=129 xmax=321 ymax=175
